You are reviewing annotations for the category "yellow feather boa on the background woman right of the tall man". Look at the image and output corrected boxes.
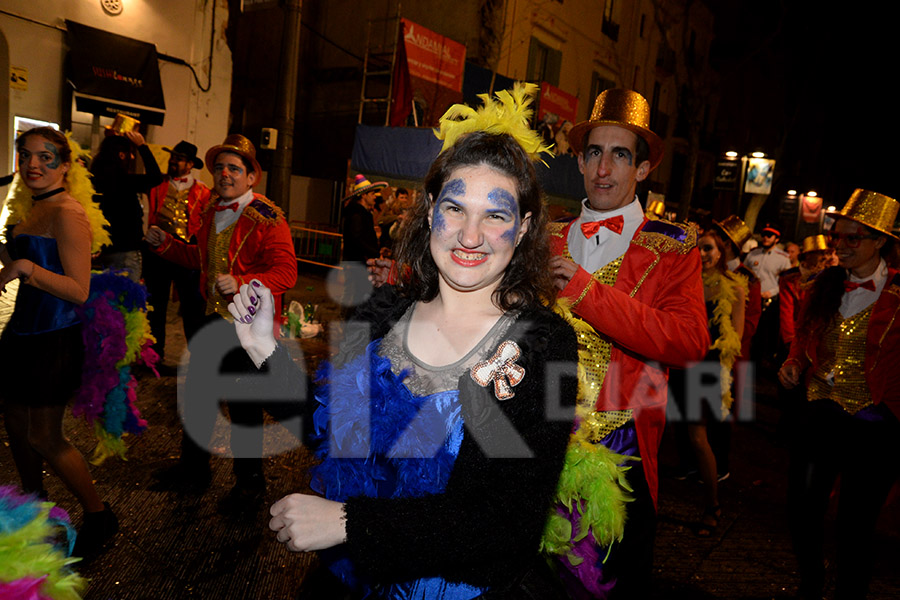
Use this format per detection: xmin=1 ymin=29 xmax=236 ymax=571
xmin=703 ymin=271 xmax=748 ymax=419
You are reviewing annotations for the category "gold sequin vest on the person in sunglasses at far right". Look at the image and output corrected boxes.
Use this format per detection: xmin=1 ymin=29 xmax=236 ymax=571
xmin=806 ymin=303 xmax=875 ymax=415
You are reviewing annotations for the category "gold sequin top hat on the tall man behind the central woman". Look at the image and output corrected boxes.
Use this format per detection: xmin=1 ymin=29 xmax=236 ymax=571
xmin=569 ymin=88 xmax=663 ymax=171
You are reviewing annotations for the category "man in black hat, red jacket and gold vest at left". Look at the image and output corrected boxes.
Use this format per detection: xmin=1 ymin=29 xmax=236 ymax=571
xmin=143 ymin=140 xmax=210 ymax=361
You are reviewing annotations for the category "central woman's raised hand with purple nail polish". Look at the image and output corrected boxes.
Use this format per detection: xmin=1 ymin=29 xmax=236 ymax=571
xmin=228 ymin=279 xmax=276 ymax=368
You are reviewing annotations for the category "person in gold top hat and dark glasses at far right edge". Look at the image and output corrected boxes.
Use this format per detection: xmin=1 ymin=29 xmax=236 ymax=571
xmin=778 ymin=190 xmax=900 ymax=598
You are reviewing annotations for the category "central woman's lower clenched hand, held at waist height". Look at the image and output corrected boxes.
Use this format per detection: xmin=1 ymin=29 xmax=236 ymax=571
xmin=269 ymin=494 xmax=347 ymax=552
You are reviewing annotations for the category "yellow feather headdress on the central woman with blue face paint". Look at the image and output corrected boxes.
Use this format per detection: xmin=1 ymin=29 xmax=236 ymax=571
xmin=434 ymin=82 xmax=553 ymax=164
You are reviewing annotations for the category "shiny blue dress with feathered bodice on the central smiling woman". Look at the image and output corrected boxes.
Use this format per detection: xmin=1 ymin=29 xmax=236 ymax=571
xmin=310 ymin=310 xmax=511 ymax=600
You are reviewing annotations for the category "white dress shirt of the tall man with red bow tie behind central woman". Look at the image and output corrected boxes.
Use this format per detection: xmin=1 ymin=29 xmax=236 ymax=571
xmin=566 ymin=196 xmax=644 ymax=273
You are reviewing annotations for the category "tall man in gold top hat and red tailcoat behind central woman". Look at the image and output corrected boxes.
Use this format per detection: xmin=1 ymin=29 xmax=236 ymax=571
xmin=550 ymin=89 xmax=710 ymax=598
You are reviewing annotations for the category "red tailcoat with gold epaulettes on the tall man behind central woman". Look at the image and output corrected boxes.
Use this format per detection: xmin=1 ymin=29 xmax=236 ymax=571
xmin=550 ymin=218 xmax=710 ymax=502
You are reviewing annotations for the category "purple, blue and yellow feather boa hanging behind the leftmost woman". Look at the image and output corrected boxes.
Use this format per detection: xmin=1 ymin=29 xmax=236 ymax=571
xmin=72 ymin=270 xmax=159 ymax=465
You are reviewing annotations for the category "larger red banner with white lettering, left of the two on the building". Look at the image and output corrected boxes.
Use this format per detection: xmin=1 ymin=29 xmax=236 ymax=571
xmin=401 ymin=19 xmax=466 ymax=92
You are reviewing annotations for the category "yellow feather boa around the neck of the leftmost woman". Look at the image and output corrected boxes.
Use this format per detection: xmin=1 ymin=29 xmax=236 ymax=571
xmin=6 ymin=132 xmax=112 ymax=254
